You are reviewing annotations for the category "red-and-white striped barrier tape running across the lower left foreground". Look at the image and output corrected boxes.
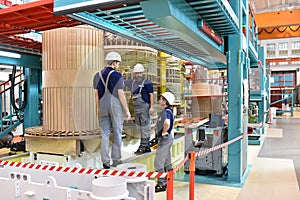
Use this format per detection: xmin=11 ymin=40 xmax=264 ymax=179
xmin=0 ymin=160 xmax=168 ymax=178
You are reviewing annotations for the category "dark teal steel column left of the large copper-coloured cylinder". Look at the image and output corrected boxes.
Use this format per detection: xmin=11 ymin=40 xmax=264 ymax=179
xmin=24 ymin=68 xmax=42 ymax=129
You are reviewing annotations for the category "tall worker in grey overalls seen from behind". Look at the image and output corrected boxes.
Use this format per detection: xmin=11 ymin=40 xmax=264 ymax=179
xmin=93 ymin=52 xmax=131 ymax=169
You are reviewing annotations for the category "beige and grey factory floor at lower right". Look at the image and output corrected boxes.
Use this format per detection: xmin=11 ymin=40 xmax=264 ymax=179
xmin=156 ymin=108 xmax=300 ymax=200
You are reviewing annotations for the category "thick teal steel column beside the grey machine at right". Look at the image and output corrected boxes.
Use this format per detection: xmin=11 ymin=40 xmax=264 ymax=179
xmin=227 ymin=1 xmax=244 ymax=182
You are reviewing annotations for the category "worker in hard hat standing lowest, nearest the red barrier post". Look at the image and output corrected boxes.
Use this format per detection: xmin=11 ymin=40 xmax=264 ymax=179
xmin=154 ymin=92 xmax=175 ymax=192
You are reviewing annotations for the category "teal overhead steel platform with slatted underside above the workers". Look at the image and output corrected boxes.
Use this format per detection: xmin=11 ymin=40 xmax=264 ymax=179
xmin=54 ymin=0 xmax=239 ymax=68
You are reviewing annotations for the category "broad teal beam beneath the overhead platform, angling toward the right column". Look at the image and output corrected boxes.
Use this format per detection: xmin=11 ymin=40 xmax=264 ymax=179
xmin=141 ymin=0 xmax=226 ymax=64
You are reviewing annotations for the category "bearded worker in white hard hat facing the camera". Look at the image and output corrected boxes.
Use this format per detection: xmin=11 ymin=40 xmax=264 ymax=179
xmin=125 ymin=63 xmax=154 ymax=154
